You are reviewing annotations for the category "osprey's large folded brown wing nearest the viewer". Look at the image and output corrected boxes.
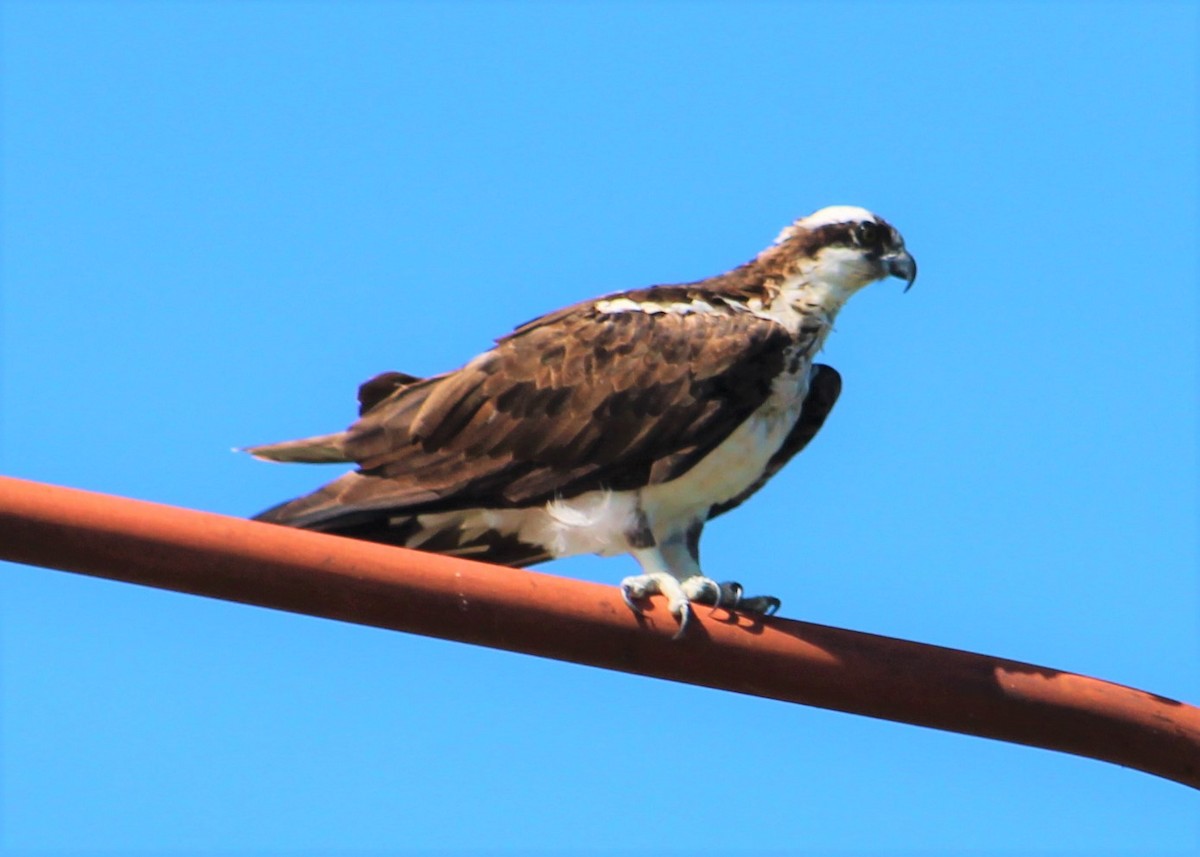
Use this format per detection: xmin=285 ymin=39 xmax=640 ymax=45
xmin=253 ymin=297 xmax=793 ymax=529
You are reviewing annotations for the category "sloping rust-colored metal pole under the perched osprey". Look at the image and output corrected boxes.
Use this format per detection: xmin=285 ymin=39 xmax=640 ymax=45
xmin=0 ymin=478 xmax=1200 ymax=787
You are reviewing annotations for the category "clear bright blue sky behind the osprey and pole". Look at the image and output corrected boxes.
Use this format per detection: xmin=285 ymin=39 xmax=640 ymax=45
xmin=0 ymin=1 xmax=1200 ymax=855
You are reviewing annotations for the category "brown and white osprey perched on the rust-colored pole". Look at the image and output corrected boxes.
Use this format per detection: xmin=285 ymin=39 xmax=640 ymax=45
xmin=246 ymin=205 xmax=917 ymax=634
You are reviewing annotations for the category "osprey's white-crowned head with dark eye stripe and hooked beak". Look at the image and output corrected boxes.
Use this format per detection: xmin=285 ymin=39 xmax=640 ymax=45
xmin=760 ymin=205 xmax=917 ymax=305
